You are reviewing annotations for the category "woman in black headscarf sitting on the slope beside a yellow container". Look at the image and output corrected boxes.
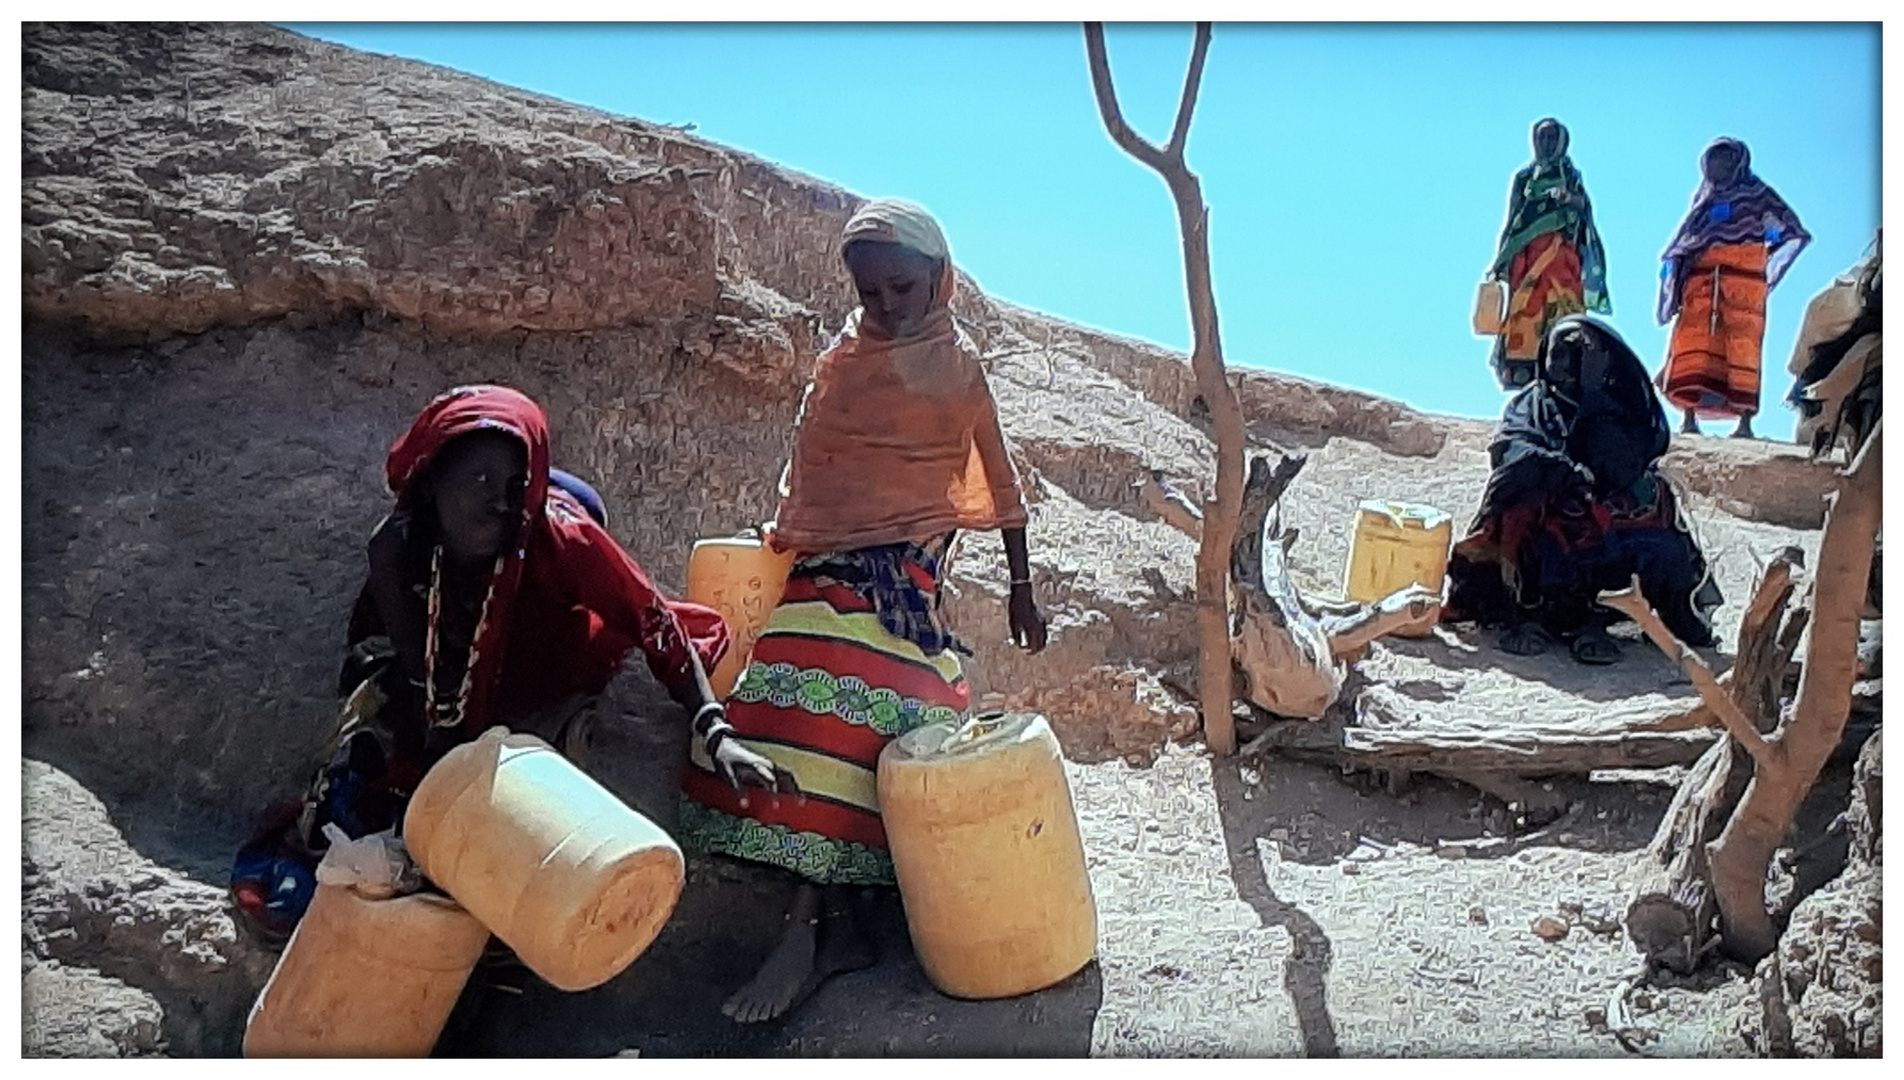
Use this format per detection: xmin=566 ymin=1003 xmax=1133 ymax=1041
xmin=1443 ymin=314 xmax=1719 ymax=665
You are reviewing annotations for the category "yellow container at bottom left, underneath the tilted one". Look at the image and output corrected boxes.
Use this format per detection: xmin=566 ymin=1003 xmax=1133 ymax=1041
xmin=244 ymin=886 xmax=489 ymax=1057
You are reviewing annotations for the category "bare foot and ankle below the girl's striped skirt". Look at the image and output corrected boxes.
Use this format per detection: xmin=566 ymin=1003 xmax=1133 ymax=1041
xmin=720 ymin=882 xmax=874 ymax=1023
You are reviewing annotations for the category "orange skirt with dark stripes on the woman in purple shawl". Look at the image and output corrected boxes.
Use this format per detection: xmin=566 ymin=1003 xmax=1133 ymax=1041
xmin=1658 ymin=244 xmax=1767 ymax=417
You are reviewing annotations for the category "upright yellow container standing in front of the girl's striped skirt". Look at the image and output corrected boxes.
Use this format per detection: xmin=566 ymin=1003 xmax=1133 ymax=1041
xmin=880 ymin=712 xmax=1097 ymax=998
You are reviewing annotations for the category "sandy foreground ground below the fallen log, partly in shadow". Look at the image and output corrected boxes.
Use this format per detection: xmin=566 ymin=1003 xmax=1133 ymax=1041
xmin=413 ymin=681 xmax=1782 ymax=1057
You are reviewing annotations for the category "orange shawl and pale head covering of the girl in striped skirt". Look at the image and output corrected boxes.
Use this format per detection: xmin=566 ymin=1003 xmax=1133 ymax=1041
xmin=773 ymin=202 xmax=1026 ymax=552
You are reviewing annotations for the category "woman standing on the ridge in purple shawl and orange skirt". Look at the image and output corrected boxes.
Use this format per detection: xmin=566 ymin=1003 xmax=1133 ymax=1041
xmin=1658 ymin=137 xmax=1811 ymax=438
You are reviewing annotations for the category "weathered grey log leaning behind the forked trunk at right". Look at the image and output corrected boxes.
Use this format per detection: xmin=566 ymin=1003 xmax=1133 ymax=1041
xmin=1626 ymin=549 xmax=1805 ymax=973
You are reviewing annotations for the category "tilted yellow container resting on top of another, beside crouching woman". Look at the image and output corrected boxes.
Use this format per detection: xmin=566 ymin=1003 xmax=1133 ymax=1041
xmin=404 ymin=728 xmax=685 ymax=990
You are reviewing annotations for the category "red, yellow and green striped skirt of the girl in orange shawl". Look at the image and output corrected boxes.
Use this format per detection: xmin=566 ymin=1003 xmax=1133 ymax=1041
xmin=680 ymin=566 xmax=971 ymax=886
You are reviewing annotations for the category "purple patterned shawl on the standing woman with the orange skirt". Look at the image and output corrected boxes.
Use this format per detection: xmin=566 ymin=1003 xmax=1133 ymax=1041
xmin=1658 ymin=137 xmax=1811 ymax=322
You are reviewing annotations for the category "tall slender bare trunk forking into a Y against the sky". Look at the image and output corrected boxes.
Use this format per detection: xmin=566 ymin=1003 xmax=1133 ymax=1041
xmin=1083 ymin=23 xmax=1243 ymax=754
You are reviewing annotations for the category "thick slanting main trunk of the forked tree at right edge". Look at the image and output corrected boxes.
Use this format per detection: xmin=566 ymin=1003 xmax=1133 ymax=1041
xmin=1708 ymin=419 xmax=1883 ymax=962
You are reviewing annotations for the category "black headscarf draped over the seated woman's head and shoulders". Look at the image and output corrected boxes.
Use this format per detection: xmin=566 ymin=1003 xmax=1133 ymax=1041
xmin=1479 ymin=314 xmax=1672 ymax=518
